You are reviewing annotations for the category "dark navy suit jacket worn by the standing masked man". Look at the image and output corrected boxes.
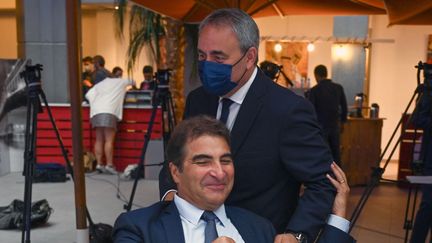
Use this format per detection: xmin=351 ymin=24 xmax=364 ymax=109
xmin=159 ymin=69 xmax=335 ymax=242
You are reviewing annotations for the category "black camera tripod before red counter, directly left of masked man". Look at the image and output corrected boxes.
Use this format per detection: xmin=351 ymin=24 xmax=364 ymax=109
xmin=124 ymin=70 xmax=176 ymax=211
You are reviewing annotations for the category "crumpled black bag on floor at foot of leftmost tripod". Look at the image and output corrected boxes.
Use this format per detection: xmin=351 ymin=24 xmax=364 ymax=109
xmin=0 ymin=199 xmax=53 ymax=229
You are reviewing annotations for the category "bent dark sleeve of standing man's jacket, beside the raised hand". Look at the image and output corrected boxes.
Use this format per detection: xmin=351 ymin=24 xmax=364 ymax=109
xmin=279 ymin=98 xmax=335 ymax=242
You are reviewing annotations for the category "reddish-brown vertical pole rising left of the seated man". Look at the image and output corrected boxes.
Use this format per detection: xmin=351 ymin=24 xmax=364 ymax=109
xmin=65 ymin=0 xmax=90 ymax=243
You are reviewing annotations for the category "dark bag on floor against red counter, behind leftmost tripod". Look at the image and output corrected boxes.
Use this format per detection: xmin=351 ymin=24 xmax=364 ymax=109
xmin=33 ymin=163 xmax=68 ymax=182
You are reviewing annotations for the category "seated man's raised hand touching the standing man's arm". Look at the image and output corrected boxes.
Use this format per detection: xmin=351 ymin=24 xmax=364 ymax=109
xmin=327 ymin=162 xmax=350 ymax=219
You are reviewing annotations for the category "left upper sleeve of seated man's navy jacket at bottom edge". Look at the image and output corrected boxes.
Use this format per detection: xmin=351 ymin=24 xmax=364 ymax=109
xmin=112 ymin=213 xmax=143 ymax=243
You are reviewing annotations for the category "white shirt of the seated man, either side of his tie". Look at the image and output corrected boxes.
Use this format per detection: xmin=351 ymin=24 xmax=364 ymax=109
xmin=174 ymin=194 xmax=244 ymax=243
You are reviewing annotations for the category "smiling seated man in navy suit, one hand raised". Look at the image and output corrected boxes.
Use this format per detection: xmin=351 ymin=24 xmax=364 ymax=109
xmin=113 ymin=116 xmax=353 ymax=243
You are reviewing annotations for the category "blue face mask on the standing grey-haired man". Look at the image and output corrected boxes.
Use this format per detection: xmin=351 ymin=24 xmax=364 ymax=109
xmin=198 ymin=52 xmax=247 ymax=96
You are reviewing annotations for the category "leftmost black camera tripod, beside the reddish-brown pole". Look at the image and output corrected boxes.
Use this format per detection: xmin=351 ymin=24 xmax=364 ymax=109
xmin=20 ymin=64 xmax=110 ymax=243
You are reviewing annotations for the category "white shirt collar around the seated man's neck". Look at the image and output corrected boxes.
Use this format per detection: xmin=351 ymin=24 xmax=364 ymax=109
xmin=174 ymin=194 xmax=228 ymax=226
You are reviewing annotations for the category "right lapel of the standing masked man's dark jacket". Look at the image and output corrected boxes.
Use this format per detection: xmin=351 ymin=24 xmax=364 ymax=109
xmin=231 ymin=69 xmax=267 ymax=156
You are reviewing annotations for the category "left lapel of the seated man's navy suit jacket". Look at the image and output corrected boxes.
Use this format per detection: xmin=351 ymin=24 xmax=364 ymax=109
xmin=160 ymin=202 xmax=185 ymax=243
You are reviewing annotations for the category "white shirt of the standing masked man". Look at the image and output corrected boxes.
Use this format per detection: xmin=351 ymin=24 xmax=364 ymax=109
xmin=216 ymin=67 xmax=258 ymax=131
